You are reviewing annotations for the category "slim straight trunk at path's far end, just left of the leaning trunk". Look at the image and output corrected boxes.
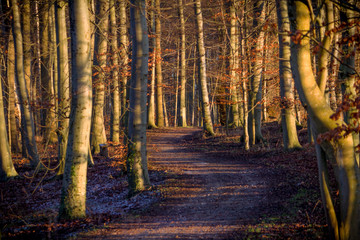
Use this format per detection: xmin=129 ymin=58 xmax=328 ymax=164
xmin=178 ymin=0 xmax=187 ymax=127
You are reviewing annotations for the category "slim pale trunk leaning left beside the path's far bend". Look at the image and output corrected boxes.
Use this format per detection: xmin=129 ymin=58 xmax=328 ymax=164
xmin=194 ymin=0 xmax=214 ymax=135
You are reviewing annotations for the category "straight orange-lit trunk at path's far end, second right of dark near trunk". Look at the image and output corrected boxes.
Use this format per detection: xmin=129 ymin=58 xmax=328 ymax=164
xmin=155 ymin=0 xmax=165 ymax=127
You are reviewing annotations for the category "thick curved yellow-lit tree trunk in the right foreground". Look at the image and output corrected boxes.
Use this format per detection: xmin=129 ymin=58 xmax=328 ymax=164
xmin=289 ymin=0 xmax=360 ymax=239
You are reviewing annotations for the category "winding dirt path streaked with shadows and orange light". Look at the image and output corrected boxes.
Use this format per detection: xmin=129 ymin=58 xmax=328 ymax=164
xmin=79 ymin=128 xmax=271 ymax=239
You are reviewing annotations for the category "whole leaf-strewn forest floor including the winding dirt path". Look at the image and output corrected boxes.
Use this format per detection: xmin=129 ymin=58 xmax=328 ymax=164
xmin=0 ymin=122 xmax=327 ymax=239
